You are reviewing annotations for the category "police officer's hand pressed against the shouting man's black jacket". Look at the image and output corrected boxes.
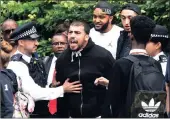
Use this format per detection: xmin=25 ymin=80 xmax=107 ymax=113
xmin=63 ymin=78 xmax=82 ymax=93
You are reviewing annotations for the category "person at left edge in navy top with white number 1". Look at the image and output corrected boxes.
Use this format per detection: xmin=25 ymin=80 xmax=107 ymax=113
xmin=0 ymin=40 xmax=17 ymax=118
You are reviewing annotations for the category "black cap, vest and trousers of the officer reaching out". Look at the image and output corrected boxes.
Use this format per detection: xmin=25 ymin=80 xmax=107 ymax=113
xmin=11 ymin=22 xmax=60 ymax=118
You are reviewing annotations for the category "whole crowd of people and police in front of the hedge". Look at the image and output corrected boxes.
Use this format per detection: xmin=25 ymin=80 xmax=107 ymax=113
xmin=0 ymin=1 xmax=170 ymax=118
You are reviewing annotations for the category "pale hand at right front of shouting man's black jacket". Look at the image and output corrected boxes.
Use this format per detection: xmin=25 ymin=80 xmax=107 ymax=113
xmin=94 ymin=77 xmax=109 ymax=87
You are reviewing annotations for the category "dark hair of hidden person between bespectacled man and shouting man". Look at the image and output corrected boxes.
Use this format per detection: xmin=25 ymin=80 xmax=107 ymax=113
xmin=55 ymin=22 xmax=70 ymax=34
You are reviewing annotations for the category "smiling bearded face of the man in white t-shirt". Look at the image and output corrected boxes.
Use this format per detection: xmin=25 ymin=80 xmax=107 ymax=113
xmin=93 ymin=8 xmax=113 ymax=33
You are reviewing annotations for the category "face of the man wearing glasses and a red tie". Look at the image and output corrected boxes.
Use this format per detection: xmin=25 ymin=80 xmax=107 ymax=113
xmin=52 ymin=34 xmax=68 ymax=53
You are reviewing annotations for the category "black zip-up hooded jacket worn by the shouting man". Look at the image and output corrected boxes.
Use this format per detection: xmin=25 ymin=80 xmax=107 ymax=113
xmin=56 ymin=39 xmax=114 ymax=118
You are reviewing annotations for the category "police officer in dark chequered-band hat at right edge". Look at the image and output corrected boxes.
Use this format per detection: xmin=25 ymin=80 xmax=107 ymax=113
xmin=146 ymin=25 xmax=170 ymax=76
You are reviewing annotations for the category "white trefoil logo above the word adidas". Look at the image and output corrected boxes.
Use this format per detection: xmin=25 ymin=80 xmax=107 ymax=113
xmin=141 ymin=98 xmax=161 ymax=112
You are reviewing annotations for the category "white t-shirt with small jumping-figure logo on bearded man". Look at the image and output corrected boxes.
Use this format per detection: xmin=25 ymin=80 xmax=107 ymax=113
xmin=90 ymin=25 xmax=123 ymax=58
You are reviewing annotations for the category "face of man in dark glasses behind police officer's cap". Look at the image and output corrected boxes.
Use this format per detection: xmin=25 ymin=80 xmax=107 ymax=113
xmin=2 ymin=21 xmax=18 ymax=42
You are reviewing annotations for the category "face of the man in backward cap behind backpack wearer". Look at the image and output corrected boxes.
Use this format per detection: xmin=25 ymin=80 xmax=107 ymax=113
xmin=120 ymin=9 xmax=137 ymax=32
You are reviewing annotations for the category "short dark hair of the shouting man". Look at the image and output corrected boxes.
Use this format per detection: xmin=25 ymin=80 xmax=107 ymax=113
xmin=70 ymin=21 xmax=90 ymax=34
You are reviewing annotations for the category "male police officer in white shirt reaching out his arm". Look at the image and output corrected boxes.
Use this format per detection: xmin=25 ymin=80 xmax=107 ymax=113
xmin=8 ymin=22 xmax=81 ymax=118
